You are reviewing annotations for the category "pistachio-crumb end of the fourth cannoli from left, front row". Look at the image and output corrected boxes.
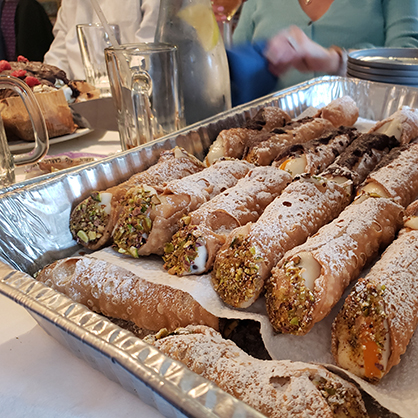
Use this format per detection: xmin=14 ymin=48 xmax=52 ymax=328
xmin=213 ymin=236 xmax=263 ymax=306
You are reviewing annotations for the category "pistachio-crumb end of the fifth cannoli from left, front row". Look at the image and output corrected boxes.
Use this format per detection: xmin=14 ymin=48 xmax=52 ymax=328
xmin=268 ymin=256 xmax=315 ymax=334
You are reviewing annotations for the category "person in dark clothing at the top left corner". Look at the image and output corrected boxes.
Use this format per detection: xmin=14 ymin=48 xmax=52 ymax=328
xmin=0 ymin=0 xmax=54 ymax=62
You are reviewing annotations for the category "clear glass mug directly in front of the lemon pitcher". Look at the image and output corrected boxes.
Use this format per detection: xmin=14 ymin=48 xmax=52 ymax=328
xmin=105 ymin=43 xmax=185 ymax=150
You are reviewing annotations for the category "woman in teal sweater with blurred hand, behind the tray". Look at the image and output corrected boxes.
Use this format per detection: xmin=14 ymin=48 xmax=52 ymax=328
xmin=231 ymin=0 xmax=418 ymax=104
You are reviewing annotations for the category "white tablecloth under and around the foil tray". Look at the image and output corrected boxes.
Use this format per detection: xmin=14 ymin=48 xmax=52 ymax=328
xmin=0 ymin=131 xmax=162 ymax=418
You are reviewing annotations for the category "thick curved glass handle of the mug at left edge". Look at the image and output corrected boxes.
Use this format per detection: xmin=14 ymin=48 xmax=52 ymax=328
xmin=0 ymin=76 xmax=49 ymax=166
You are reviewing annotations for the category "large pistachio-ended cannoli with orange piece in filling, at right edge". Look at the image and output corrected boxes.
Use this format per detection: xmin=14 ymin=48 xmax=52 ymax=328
xmin=332 ymin=201 xmax=418 ymax=382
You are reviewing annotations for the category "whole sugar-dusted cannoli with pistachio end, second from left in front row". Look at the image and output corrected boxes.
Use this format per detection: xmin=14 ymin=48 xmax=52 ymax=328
xmin=112 ymin=159 xmax=254 ymax=258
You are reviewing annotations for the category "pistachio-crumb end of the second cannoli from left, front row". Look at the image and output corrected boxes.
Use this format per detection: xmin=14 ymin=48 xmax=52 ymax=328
xmin=113 ymin=186 xmax=161 ymax=258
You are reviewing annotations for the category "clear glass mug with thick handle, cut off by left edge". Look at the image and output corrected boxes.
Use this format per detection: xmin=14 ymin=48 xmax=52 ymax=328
xmin=0 ymin=75 xmax=49 ymax=187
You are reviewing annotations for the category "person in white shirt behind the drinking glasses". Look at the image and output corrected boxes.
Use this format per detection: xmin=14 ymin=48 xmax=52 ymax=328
xmin=44 ymin=0 xmax=160 ymax=80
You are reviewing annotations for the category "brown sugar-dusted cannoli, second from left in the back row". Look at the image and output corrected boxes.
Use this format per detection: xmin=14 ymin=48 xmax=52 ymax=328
xmin=244 ymin=117 xmax=334 ymax=165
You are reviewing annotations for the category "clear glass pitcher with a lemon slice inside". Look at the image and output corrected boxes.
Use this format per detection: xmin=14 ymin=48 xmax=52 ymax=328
xmin=155 ymin=0 xmax=231 ymax=125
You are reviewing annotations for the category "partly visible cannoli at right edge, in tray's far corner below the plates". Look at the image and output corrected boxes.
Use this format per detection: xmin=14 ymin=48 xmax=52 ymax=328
xmin=369 ymin=106 xmax=418 ymax=144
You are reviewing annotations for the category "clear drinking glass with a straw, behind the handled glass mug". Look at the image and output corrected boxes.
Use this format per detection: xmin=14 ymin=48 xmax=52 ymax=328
xmin=77 ymin=23 xmax=120 ymax=97
